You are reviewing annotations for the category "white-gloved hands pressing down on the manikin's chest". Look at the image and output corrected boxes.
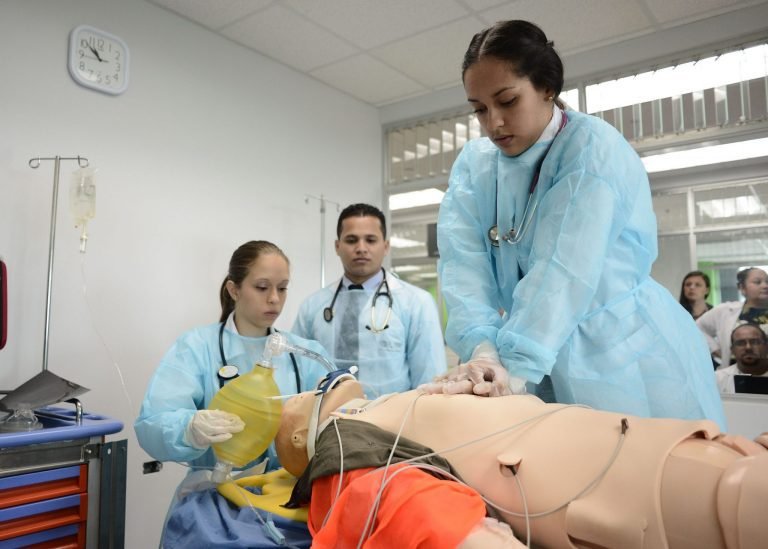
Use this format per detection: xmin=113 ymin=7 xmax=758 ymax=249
xmin=419 ymin=341 xmax=526 ymax=397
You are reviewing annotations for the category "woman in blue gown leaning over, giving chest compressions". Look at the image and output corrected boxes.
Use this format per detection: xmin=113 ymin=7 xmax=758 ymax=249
xmin=426 ymin=21 xmax=725 ymax=427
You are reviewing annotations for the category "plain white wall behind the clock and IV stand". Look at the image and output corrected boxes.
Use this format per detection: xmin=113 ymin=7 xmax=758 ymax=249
xmin=0 ymin=0 xmax=381 ymax=547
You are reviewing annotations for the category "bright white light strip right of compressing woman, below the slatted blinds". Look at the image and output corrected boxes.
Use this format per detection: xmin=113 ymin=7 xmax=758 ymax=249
xmin=641 ymin=137 xmax=768 ymax=173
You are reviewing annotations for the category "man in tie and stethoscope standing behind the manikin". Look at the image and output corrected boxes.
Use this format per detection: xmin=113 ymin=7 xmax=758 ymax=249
xmin=293 ymin=204 xmax=446 ymax=396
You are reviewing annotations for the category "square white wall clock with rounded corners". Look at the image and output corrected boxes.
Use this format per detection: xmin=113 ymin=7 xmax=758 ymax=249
xmin=69 ymin=25 xmax=128 ymax=95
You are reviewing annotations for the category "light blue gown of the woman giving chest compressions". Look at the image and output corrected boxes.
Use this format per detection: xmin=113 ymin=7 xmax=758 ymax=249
xmin=438 ymin=111 xmax=725 ymax=429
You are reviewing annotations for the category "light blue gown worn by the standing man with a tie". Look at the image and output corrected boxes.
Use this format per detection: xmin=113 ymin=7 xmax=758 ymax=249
xmin=293 ymin=272 xmax=446 ymax=397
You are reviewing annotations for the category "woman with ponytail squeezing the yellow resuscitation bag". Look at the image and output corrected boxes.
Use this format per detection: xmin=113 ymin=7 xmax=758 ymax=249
xmin=134 ymin=240 xmax=328 ymax=548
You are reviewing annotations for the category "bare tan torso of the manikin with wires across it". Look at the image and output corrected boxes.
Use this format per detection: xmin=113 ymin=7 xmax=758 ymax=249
xmin=330 ymin=391 xmax=768 ymax=549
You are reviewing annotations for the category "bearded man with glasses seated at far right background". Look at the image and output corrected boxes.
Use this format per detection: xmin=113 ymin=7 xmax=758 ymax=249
xmin=715 ymin=322 xmax=768 ymax=395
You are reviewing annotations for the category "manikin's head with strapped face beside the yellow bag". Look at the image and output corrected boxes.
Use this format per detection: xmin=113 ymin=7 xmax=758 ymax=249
xmin=275 ymin=379 xmax=364 ymax=476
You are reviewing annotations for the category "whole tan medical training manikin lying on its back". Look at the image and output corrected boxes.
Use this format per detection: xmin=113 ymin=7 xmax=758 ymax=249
xmin=276 ymin=381 xmax=768 ymax=549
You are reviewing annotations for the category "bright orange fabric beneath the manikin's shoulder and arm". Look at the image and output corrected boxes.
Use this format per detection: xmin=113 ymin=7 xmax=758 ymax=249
xmin=309 ymin=464 xmax=485 ymax=549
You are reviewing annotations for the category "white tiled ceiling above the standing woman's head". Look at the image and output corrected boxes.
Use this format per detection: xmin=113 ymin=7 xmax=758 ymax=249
xmin=148 ymin=0 xmax=766 ymax=107
